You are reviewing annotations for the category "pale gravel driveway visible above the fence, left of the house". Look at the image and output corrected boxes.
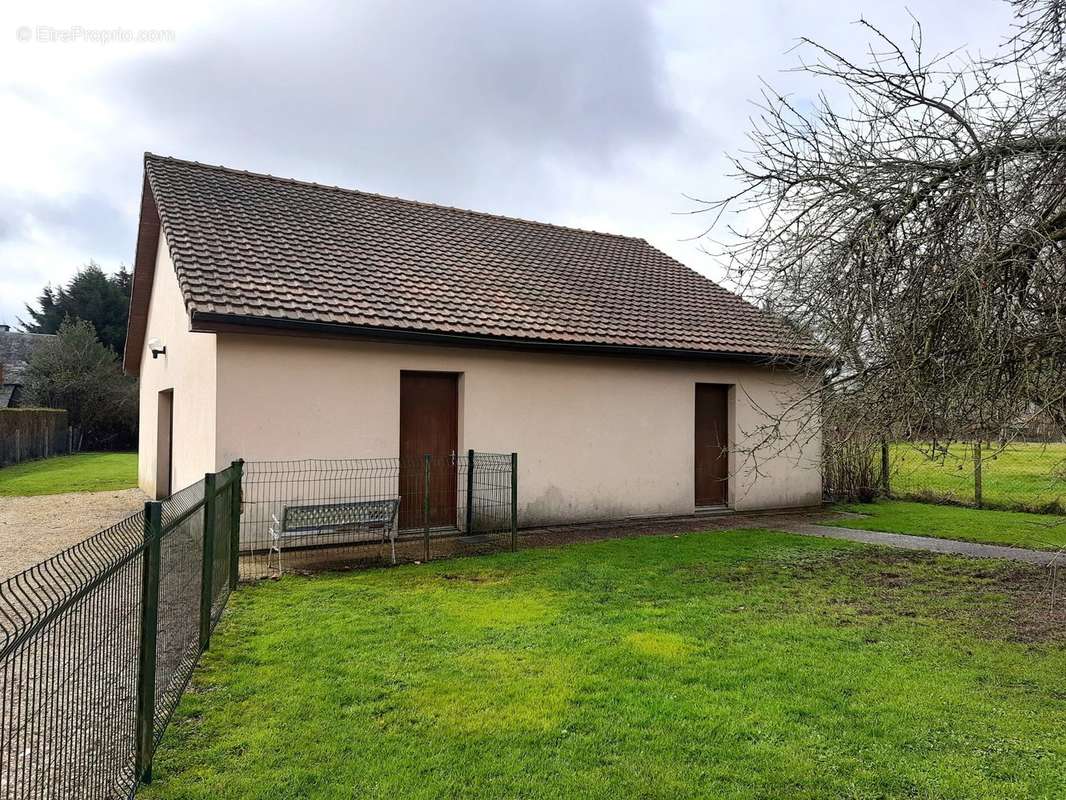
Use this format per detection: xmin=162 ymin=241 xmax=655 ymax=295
xmin=0 ymin=489 xmax=147 ymax=580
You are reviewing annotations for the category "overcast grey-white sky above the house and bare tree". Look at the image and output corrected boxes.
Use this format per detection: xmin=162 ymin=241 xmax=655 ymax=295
xmin=0 ymin=0 xmax=1010 ymax=323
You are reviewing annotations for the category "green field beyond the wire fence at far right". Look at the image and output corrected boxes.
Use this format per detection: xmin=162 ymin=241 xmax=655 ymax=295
xmin=891 ymin=444 xmax=1066 ymax=513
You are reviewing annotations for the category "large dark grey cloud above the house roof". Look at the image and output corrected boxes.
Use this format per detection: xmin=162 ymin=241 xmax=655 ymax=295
xmin=108 ymin=0 xmax=679 ymax=204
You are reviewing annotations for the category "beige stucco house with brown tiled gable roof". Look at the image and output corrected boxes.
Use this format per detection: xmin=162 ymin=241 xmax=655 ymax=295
xmin=124 ymin=154 xmax=822 ymax=525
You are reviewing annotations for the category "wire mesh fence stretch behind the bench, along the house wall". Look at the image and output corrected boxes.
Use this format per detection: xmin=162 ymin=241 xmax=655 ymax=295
xmin=240 ymin=451 xmax=516 ymax=578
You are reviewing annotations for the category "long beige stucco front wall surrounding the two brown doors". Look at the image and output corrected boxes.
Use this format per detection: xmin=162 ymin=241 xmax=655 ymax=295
xmin=212 ymin=332 xmax=821 ymax=525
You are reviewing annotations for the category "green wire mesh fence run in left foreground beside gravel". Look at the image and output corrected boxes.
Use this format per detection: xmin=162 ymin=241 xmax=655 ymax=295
xmin=0 ymin=462 xmax=242 ymax=800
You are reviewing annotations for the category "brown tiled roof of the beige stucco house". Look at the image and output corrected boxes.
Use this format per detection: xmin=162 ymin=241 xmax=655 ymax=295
xmin=126 ymin=154 xmax=815 ymax=371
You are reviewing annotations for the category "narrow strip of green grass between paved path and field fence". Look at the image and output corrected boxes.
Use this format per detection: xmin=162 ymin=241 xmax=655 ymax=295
xmin=829 ymin=500 xmax=1066 ymax=550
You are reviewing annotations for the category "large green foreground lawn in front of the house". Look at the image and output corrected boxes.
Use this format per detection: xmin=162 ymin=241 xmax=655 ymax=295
xmin=140 ymin=531 xmax=1066 ymax=800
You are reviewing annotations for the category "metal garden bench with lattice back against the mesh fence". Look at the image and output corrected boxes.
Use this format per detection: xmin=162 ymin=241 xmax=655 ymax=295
xmin=270 ymin=497 xmax=400 ymax=573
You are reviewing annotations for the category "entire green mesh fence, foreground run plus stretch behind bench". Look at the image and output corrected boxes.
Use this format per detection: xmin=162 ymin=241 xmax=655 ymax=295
xmin=0 ymin=450 xmax=518 ymax=800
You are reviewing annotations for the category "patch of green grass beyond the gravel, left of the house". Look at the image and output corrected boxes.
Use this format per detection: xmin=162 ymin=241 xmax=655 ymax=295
xmin=0 ymin=452 xmax=136 ymax=496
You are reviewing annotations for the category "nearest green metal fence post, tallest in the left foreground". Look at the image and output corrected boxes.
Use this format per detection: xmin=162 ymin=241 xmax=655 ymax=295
xmin=135 ymin=501 xmax=163 ymax=783
